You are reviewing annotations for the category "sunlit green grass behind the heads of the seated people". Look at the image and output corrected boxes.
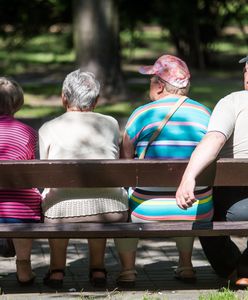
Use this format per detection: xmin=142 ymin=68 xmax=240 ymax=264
xmin=0 ymin=27 xmax=247 ymax=118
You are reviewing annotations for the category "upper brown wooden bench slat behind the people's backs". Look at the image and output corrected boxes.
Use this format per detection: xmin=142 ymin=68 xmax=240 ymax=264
xmin=0 ymin=159 xmax=245 ymax=188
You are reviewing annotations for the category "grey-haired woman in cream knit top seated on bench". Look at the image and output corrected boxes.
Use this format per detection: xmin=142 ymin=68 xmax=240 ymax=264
xmin=39 ymin=70 xmax=135 ymax=288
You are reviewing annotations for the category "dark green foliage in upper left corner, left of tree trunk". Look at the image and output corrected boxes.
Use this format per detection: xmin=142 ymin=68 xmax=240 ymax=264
xmin=0 ymin=0 xmax=72 ymax=48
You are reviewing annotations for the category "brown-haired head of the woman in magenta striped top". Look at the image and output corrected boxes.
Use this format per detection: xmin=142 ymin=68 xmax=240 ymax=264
xmin=0 ymin=77 xmax=24 ymax=115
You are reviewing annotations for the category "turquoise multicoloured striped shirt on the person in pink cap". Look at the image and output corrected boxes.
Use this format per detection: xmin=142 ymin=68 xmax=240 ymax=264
xmin=125 ymin=97 xmax=213 ymax=221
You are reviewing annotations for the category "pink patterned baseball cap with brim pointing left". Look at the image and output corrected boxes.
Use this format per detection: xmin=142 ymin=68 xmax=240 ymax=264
xmin=139 ymin=55 xmax=190 ymax=88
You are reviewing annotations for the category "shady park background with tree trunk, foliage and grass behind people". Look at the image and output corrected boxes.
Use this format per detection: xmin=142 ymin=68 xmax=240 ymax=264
xmin=0 ymin=0 xmax=248 ymax=127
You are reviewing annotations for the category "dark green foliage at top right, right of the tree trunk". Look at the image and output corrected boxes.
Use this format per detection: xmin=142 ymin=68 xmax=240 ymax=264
xmin=121 ymin=0 xmax=248 ymax=69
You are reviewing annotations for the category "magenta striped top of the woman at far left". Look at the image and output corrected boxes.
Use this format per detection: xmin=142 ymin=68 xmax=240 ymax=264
xmin=0 ymin=115 xmax=41 ymax=221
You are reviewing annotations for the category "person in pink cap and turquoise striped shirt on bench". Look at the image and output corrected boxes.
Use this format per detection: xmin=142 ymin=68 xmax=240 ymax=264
xmin=121 ymin=55 xmax=213 ymax=282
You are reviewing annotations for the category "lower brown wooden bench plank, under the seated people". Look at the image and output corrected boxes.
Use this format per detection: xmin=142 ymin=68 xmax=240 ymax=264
xmin=0 ymin=222 xmax=248 ymax=238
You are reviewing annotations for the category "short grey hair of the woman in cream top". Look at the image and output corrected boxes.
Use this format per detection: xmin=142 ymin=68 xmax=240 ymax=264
xmin=62 ymin=69 xmax=100 ymax=109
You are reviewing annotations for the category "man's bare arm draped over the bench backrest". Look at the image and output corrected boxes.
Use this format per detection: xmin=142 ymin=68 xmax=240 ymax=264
xmin=176 ymin=131 xmax=226 ymax=209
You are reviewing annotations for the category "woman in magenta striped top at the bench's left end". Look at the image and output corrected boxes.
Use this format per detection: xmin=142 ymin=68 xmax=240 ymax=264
xmin=0 ymin=77 xmax=41 ymax=285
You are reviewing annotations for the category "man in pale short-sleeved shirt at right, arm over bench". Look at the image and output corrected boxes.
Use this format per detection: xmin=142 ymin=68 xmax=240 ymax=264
xmin=176 ymin=56 xmax=248 ymax=286
